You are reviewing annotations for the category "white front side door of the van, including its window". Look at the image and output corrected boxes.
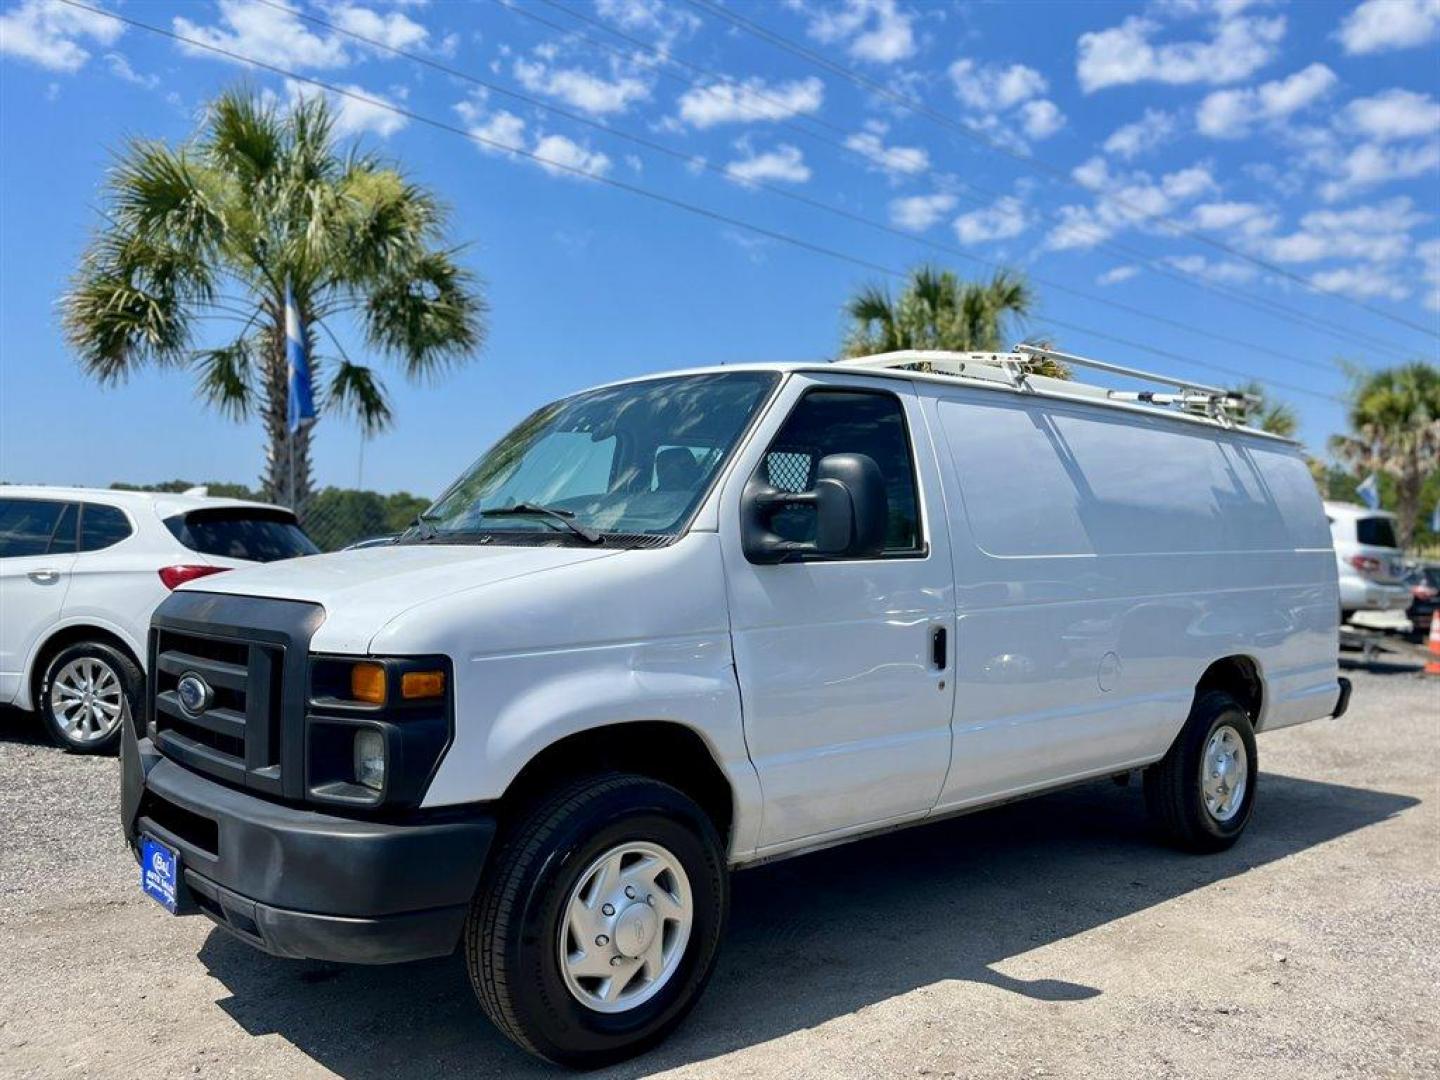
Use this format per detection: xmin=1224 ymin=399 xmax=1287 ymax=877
xmin=720 ymin=374 xmax=953 ymax=848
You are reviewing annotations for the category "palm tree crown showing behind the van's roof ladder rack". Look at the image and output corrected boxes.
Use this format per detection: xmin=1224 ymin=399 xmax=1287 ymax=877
xmin=842 ymin=266 xmax=1068 ymax=379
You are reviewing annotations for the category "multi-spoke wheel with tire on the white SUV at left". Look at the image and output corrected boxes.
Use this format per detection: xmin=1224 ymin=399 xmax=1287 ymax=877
xmin=36 ymin=641 xmax=144 ymax=753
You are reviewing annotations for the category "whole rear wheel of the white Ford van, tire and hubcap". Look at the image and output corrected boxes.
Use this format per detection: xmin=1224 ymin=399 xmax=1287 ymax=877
xmin=1145 ymin=690 xmax=1260 ymax=852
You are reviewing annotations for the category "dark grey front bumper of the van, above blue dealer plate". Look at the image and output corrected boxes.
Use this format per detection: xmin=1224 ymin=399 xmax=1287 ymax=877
xmin=121 ymin=724 xmax=495 ymax=963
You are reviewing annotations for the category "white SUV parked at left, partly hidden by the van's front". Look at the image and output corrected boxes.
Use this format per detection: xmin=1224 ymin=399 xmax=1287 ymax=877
xmin=0 ymin=485 xmax=317 ymax=753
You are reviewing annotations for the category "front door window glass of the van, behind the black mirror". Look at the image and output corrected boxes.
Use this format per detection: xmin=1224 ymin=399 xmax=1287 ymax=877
xmin=762 ymin=390 xmax=920 ymax=554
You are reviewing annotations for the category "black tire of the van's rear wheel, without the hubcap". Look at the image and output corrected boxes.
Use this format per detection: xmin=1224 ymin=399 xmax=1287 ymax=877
xmin=1145 ymin=690 xmax=1260 ymax=852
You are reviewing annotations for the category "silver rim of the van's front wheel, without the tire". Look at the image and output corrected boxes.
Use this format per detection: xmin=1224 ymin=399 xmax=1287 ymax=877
xmin=560 ymin=841 xmax=696 ymax=1012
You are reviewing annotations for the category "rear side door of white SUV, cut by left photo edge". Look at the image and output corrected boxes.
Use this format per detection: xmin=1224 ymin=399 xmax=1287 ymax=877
xmin=0 ymin=498 xmax=78 ymax=704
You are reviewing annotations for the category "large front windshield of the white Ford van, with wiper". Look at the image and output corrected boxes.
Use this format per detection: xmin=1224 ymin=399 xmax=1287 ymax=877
xmin=400 ymin=372 xmax=776 ymax=543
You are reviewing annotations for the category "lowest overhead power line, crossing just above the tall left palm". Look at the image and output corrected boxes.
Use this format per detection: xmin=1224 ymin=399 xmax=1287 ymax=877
xmin=60 ymin=0 xmax=1341 ymax=402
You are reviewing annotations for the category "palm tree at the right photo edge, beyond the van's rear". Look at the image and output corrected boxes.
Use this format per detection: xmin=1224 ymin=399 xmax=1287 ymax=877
xmin=1331 ymin=360 xmax=1440 ymax=547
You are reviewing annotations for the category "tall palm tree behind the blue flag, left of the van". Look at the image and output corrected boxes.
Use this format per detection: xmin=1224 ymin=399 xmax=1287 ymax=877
xmin=62 ymin=91 xmax=487 ymax=508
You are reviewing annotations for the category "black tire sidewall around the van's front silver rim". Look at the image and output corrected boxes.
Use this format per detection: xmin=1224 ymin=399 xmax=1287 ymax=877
xmin=505 ymin=785 xmax=727 ymax=1066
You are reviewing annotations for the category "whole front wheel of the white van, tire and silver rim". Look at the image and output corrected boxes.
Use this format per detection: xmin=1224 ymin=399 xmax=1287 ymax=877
xmin=465 ymin=773 xmax=727 ymax=1068
